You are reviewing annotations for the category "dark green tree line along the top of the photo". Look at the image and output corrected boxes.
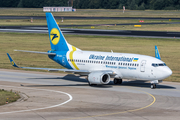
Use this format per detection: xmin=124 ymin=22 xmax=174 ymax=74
xmin=0 ymin=0 xmax=180 ymax=10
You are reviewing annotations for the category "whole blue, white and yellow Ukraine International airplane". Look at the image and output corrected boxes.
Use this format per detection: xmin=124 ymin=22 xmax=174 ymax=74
xmin=7 ymin=13 xmax=172 ymax=89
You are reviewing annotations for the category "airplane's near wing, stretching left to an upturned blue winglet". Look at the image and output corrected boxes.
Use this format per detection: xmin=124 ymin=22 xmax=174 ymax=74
xmin=7 ymin=53 xmax=116 ymax=76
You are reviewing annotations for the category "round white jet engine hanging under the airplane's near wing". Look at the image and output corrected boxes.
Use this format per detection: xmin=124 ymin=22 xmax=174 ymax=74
xmin=88 ymin=72 xmax=110 ymax=85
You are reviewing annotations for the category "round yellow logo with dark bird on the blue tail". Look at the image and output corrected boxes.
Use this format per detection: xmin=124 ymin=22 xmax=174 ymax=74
xmin=50 ymin=28 xmax=60 ymax=45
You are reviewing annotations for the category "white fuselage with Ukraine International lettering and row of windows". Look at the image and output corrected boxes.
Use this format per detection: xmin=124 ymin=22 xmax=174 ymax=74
xmin=66 ymin=51 xmax=172 ymax=81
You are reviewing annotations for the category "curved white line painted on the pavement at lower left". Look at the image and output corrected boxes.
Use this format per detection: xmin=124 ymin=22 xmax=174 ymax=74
xmin=0 ymin=85 xmax=73 ymax=115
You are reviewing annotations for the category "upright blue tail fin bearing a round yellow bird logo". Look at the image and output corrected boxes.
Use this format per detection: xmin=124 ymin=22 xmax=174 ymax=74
xmin=46 ymin=13 xmax=71 ymax=51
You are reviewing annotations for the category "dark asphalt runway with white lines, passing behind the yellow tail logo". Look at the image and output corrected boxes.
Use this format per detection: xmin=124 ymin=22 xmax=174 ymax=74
xmin=0 ymin=26 xmax=180 ymax=39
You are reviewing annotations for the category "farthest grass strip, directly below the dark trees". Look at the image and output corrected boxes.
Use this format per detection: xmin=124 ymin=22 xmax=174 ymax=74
xmin=0 ymin=8 xmax=180 ymax=18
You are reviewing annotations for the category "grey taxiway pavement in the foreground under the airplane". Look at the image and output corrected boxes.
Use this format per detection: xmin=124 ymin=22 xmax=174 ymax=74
xmin=0 ymin=69 xmax=180 ymax=120
